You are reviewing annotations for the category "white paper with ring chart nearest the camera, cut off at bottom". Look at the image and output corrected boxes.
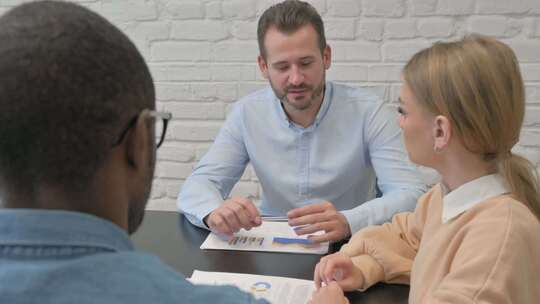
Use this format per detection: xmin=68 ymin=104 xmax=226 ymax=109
xmin=189 ymin=270 xmax=315 ymax=304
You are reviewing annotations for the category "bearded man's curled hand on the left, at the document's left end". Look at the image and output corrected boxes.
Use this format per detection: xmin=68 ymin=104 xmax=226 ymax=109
xmin=204 ymin=197 xmax=262 ymax=236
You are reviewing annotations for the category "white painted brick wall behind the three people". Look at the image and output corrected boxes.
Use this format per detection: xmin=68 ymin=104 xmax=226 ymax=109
xmin=0 ymin=0 xmax=540 ymax=210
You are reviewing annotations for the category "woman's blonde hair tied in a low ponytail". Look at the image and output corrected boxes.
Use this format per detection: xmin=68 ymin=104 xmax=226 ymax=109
xmin=403 ymin=35 xmax=540 ymax=220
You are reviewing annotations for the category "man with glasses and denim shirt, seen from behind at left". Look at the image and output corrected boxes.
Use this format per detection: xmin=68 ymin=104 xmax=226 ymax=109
xmin=0 ymin=1 xmax=266 ymax=304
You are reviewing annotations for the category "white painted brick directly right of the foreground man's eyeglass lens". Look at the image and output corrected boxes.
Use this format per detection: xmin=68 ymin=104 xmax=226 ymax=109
xmin=167 ymin=121 xmax=222 ymax=142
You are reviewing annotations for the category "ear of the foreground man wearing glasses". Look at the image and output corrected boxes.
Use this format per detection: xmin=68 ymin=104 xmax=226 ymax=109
xmin=126 ymin=110 xmax=152 ymax=169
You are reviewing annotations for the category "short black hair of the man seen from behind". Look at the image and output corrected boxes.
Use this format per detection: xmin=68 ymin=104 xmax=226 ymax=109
xmin=0 ymin=1 xmax=155 ymax=191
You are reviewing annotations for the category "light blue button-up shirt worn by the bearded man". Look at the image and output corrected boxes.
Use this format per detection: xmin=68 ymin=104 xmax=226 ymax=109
xmin=177 ymin=82 xmax=426 ymax=233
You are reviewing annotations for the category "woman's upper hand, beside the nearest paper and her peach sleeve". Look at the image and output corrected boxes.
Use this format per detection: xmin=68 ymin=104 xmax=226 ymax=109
xmin=313 ymin=252 xmax=364 ymax=291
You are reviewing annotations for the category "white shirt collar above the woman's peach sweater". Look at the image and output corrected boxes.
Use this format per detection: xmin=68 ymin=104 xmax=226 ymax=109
xmin=441 ymin=174 xmax=510 ymax=223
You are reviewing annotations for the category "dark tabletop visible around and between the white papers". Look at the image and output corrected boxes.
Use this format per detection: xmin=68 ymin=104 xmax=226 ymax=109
xmin=132 ymin=211 xmax=409 ymax=304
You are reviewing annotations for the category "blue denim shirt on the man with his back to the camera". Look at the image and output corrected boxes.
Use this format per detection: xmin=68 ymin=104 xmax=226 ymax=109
xmin=0 ymin=209 xmax=267 ymax=304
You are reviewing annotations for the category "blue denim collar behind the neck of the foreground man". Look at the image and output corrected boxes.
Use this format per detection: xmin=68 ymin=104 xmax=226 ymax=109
xmin=0 ymin=209 xmax=134 ymax=251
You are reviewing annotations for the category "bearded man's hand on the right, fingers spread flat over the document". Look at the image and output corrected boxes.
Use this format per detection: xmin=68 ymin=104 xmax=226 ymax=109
xmin=287 ymin=202 xmax=351 ymax=243
